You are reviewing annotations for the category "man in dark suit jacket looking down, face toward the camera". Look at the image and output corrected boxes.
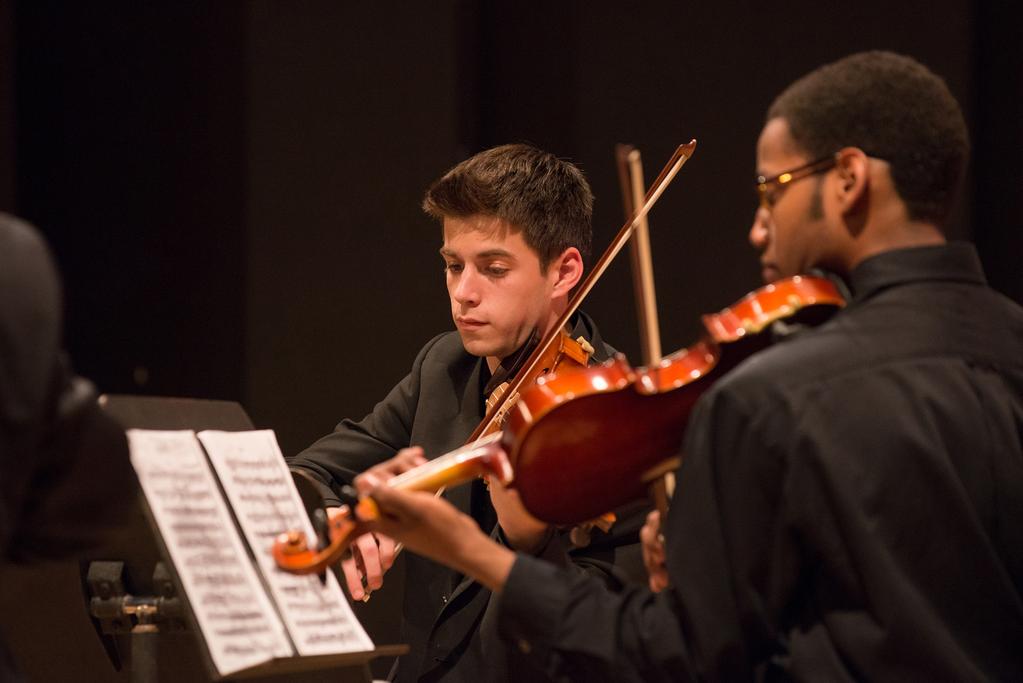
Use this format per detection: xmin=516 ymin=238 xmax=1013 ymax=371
xmin=290 ymin=145 xmax=634 ymax=681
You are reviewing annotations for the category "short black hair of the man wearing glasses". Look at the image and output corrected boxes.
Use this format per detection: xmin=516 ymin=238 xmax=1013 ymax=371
xmin=767 ymin=51 xmax=970 ymax=225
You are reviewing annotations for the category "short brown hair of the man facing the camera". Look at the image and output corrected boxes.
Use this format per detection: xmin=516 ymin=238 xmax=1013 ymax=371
xmin=422 ymin=144 xmax=593 ymax=270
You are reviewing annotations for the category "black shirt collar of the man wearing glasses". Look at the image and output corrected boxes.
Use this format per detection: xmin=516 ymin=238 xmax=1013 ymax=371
xmin=849 ymin=242 xmax=986 ymax=301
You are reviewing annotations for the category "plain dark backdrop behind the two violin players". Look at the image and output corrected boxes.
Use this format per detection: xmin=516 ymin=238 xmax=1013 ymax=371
xmin=0 ymin=0 xmax=1023 ymax=670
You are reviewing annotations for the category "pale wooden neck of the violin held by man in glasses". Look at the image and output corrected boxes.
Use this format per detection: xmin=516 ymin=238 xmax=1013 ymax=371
xmin=388 ymin=431 xmax=512 ymax=492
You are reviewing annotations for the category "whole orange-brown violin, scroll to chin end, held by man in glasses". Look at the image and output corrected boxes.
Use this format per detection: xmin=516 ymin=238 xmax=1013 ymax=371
xmin=272 ymin=276 xmax=845 ymax=574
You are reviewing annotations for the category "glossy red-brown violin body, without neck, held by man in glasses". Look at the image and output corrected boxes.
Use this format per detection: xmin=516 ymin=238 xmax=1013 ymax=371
xmin=505 ymin=276 xmax=845 ymax=525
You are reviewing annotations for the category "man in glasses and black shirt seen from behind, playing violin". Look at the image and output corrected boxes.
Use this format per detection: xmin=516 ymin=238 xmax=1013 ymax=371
xmin=357 ymin=52 xmax=1023 ymax=683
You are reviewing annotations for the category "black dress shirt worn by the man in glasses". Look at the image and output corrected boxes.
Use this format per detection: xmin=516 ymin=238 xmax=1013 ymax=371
xmin=499 ymin=244 xmax=1023 ymax=683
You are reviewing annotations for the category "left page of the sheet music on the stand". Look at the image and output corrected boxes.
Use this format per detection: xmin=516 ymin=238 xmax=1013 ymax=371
xmin=128 ymin=429 xmax=294 ymax=676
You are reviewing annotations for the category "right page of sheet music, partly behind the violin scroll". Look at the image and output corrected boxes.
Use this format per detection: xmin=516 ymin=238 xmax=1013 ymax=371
xmin=198 ymin=429 xmax=373 ymax=654
